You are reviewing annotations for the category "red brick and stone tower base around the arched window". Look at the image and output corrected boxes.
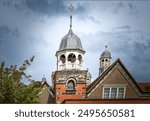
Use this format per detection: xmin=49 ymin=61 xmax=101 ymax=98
xmin=55 ymin=70 xmax=87 ymax=103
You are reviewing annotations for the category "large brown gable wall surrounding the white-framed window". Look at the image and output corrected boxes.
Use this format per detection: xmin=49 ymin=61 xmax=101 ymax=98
xmin=87 ymin=59 xmax=144 ymax=99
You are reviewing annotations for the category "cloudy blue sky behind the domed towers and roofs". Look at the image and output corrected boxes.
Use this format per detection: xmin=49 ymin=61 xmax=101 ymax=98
xmin=0 ymin=0 xmax=150 ymax=83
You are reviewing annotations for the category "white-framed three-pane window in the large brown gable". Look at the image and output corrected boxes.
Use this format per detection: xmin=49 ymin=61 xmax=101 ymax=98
xmin=103 ymin=87 xmax=125 ymax=99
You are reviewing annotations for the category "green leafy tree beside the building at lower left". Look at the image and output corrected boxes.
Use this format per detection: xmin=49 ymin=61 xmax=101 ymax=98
xmin=0 ymin=56 xmax=41 ymax=104
